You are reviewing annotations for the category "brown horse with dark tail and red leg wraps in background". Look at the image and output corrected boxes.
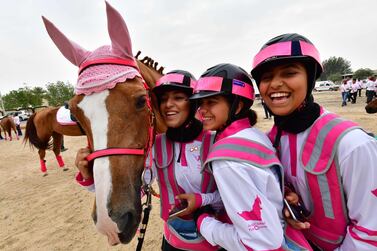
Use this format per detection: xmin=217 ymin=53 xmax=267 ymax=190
xmin=24 ymin=107 xmax=84 ymax=175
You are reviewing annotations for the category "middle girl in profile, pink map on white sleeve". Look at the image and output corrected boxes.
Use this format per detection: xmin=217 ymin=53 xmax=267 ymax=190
xmin=191 ymin=64 xmax=310 ymax=250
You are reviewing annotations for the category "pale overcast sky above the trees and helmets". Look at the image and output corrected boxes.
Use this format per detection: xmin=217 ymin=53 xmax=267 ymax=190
xmin=0 ymin=0 xmax=377 ymax=94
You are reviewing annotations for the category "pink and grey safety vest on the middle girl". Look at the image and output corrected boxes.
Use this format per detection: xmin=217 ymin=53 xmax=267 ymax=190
xmin=204 ymin=137 xmax=312 ymax=250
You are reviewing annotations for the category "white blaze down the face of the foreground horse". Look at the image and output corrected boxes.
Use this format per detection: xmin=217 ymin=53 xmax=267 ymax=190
xmin=78 ymin=90 xmax=120 ymax=245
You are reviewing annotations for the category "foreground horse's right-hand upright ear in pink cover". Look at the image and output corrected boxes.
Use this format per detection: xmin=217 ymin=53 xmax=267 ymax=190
xmin=106 ymin=2 xmax=133 ymax=59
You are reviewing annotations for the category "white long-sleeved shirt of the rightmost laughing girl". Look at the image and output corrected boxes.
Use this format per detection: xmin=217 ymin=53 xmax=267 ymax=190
xmin=280 ymin=110 xmax=377 ymax=251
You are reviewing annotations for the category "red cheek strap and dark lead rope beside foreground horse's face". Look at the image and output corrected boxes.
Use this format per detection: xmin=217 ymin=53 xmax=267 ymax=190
xmin=136 ymin=81 xmax=155 ymax=251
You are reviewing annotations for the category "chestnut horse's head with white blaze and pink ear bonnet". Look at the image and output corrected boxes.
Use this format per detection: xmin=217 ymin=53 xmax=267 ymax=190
xmin=42 ymin=2 xmax=162 ymax=245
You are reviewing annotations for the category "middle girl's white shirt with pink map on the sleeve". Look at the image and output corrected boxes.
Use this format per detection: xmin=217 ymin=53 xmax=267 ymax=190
xmin=200 ymin=128 xmax=284 ymax=250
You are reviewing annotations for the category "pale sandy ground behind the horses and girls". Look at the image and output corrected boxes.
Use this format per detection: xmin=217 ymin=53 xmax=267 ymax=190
xmin=0 ymin=92 xmax=377 ymax=251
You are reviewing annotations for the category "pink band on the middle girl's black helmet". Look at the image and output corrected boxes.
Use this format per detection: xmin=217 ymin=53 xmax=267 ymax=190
xmin=191 ymin=76 xmax=255 ymax=100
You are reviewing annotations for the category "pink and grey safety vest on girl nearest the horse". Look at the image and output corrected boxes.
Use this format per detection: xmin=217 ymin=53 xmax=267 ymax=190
xmin=154 ymin=132 xmax=219 ymax=251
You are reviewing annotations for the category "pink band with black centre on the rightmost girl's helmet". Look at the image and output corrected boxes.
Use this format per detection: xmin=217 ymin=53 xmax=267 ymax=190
xmin=251 ymin=40 xmax=323 ymax=82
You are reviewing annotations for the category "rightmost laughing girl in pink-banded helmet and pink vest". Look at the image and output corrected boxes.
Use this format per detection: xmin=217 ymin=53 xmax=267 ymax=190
xmin=251 ymin=34 xmax=377 ymax=251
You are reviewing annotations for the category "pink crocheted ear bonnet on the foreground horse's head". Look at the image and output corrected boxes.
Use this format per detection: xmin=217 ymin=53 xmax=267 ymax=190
xmin=42 ymin=2 xmax=141 ymax=95
